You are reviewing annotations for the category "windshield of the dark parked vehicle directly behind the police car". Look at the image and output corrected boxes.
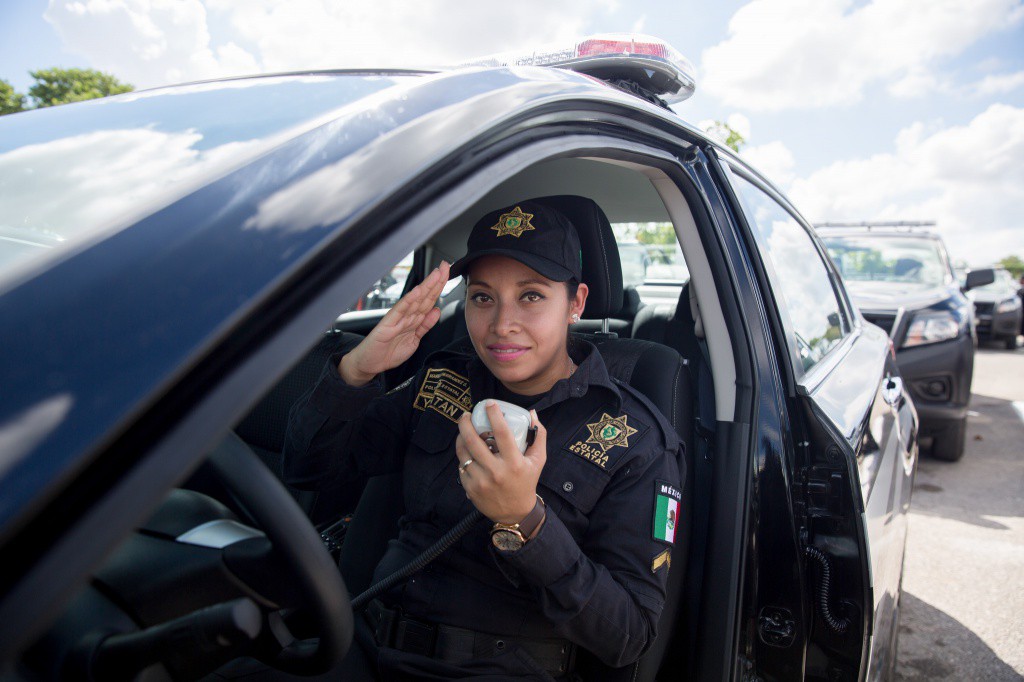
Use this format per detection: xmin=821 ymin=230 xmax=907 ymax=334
xmin=823 ymin=235 xmax=952 ymax=289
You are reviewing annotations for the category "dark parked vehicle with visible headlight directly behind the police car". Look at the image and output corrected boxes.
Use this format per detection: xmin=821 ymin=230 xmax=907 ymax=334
xmin=818 ymin=227 xmax=993 ymax=461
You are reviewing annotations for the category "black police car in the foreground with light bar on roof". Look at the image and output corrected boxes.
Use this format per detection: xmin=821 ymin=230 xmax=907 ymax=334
xmin=0 ymin=35 xmax=918 ymax=680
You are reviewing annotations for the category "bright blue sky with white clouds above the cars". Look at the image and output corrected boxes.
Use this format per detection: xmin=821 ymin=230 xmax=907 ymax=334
xmin=0 ymin=0 xmax=1024 ymax=266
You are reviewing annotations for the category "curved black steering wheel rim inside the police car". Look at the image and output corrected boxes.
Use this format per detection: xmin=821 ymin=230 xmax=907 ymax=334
xmin=209 ymin=431 xmax=353 ymax=675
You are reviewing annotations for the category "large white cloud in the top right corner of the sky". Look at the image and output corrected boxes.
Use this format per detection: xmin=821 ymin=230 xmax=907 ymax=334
xmin=701 ymin=0 xmax=1024 ymax=111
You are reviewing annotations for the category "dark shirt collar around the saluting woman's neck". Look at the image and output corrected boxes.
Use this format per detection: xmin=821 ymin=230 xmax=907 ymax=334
xmin=467 ymin=338 xmax=623 ymax=412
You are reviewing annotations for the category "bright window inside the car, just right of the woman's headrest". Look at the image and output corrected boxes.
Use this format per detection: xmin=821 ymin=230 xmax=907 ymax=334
xmin=611 ymin=222 xmax=690 ymax=303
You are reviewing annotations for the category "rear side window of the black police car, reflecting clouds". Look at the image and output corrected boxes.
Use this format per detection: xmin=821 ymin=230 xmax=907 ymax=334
xmin=732 ymin=175 xmax=849 ymax=370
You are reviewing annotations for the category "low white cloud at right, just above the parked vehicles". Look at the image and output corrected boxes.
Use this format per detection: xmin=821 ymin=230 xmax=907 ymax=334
xmin=788 ymin=104 xmax=1024 ymax=265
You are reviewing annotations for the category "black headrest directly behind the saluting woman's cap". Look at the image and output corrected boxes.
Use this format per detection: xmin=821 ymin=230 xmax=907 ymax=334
xmin=534 ymin=195 xmax=623 ymax=319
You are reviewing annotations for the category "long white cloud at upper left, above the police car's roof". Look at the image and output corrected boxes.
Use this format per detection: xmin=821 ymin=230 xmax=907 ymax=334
xmin=45 ymin=0 xmax=618 ymax=86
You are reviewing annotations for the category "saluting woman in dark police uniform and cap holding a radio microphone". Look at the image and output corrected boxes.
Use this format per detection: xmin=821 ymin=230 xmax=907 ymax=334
xmin=285 ymin=201 xmax=685 ymax=680
